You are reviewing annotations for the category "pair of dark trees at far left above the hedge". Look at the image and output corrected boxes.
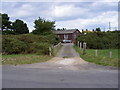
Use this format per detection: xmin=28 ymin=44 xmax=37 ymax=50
xmin=0 ymin=14 xmax=29 ymax=35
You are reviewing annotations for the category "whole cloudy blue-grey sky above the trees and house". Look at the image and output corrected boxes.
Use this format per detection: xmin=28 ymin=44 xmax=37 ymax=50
xmin=2 ymin=2 xmax=118 ymax=32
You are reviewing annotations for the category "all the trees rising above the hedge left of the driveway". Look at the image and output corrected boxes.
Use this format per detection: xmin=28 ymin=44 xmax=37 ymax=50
xmin=0 ymin=13 xmax=55 ymax=35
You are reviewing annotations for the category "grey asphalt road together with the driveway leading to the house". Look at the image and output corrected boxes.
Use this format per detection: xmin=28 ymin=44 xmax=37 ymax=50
xmin=2 ymin=44 xmax=118 ymax=88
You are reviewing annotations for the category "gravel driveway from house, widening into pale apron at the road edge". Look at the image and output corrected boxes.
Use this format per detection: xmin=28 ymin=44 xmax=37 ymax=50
xmin=18 ymin=43 xmax=117 ymax=70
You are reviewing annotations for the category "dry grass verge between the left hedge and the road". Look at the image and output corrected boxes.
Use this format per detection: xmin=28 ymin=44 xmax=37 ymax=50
xmin=2 ymin=54 xmax=52 ymax=65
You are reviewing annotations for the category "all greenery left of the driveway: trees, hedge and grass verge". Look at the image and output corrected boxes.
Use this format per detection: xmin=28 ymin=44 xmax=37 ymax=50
xmin=0 ymin=14 xmax=59 ymax=64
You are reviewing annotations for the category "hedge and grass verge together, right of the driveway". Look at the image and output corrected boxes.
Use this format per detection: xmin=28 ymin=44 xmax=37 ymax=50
xmin=74 ymin=28 xmax=120 ymax=67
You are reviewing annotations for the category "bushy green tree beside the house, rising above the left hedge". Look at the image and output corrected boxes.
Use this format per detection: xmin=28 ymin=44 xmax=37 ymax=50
xmin=32 ymin=18 xmax=55 ymax=35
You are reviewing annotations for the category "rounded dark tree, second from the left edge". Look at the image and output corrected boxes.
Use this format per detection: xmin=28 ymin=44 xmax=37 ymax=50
xmin=13 ymin=19 xmax=29 ymax=34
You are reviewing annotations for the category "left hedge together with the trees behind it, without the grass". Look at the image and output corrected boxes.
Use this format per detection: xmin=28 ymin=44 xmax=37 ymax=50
xmin=2 ymin=14 xmax=59 ymax=55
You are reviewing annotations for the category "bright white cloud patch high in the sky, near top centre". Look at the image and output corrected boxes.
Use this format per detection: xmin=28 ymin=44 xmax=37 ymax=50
xmin=52 ymin=5 xmax=88 ymax=17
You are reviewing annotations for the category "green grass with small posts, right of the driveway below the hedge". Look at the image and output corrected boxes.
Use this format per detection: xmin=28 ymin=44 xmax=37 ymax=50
xmin=74 ymin=45 xmax=120 ymax=67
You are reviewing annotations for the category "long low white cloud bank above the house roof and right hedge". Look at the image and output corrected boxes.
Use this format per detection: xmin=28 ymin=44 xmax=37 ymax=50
xmin=56 ymin=11 xmax=118 ymax=30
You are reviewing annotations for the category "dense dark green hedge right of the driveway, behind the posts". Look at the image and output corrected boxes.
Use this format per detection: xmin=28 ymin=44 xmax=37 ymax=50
xmin=76 ymin=31 xmax=120 ymax=49
